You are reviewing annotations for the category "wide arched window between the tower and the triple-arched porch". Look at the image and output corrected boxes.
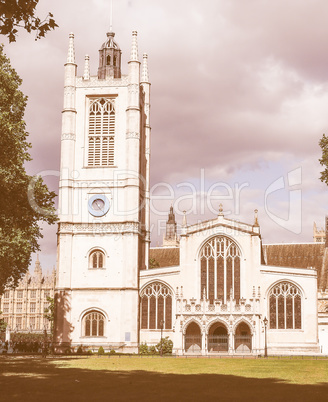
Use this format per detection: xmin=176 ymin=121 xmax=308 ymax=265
xmin=140 ymin=282 xmax=172 ymax=329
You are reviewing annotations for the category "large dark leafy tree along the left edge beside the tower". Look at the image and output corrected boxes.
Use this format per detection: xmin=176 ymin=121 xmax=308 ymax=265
xmin=0 ymin=46 xmax=57 ymax=294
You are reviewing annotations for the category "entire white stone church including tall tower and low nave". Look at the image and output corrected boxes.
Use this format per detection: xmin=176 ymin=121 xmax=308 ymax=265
xmin=55 ymin=32 xmax=319 ymax=355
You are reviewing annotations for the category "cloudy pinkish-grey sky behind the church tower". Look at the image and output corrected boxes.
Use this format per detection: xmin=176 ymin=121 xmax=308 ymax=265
xmin=3 ymin=0 xmax=328 ymax=274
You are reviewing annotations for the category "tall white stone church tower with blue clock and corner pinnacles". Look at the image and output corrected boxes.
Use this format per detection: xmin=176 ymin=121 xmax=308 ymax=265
xmin=55 ymin=32 xmax=150 ymax=351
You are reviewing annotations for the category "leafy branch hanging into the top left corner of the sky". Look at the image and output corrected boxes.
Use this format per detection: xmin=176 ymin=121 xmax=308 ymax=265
xmin=0 ymin=0 xmax=58 ymax=42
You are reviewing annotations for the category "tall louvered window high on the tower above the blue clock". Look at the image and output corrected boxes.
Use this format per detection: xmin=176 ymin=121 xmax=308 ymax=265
xmin=88 ymin=98 xmax=115 ymax=167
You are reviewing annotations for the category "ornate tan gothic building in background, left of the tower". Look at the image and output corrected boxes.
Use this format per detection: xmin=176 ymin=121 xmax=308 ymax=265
xmin=0 ymin=257 xmax=56 ymax=333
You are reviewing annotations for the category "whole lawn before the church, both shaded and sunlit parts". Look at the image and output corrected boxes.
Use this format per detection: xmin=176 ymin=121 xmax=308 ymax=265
xmin=0 ymin=356 xmax=328 ymax=402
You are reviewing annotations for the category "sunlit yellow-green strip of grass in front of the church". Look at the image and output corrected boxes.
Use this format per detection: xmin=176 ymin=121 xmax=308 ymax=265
xmin=53 ymin=356 xmax=328 ymax=384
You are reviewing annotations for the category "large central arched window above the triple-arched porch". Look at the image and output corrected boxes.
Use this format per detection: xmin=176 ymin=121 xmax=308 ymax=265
xmin=200 ymin=236 xmax=240 ymax=303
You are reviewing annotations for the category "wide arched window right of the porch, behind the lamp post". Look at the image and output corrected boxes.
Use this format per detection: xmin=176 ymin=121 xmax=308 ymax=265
xmin=269 ymin=282 xmax=302 ymax=329
